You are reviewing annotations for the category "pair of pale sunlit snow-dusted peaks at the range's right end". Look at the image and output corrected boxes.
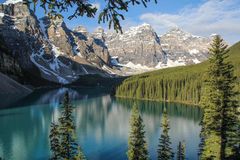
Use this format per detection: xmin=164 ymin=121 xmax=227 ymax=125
xmin=104 ymin=24 xmax=211 ymax=72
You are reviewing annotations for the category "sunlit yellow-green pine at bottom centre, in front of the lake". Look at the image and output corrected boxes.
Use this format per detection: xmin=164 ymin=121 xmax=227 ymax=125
xmin=127 ymin=105 xmax=149 ymax=160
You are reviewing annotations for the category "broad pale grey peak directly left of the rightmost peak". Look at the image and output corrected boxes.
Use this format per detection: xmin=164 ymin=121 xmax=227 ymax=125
xmin=105 ymin=24 xmax=164 ymax=67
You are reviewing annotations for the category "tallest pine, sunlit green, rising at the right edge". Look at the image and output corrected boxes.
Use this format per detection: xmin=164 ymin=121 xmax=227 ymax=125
xmin=200 ymin=36 xmax=239 ymax=160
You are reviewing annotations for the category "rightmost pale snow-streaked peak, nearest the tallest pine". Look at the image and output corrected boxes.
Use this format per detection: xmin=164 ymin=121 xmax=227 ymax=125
xmin=160 ymin=28 xmax=211 ymax=65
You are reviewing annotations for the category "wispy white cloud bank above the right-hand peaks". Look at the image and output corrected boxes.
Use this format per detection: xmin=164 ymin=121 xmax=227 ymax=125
xmin=140 ymin=0 xmax=240 ymax=43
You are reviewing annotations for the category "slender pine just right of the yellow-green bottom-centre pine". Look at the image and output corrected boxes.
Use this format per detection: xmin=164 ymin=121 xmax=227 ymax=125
xmin=158 ymin=108 xmax=174 ymax=160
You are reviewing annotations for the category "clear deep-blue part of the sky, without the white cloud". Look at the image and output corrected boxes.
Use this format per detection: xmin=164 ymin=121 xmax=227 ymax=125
xmin=29 ymin=0 xmax=202 ymax=31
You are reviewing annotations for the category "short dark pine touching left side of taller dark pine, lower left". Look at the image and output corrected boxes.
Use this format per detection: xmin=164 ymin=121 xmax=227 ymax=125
xmin=49 ymin=123 xmax=61 ymax=160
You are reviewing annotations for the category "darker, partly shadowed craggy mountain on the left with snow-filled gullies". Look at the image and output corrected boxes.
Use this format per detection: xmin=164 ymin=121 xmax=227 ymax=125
xmin=0 ymin=0 xmax=111 ymax=84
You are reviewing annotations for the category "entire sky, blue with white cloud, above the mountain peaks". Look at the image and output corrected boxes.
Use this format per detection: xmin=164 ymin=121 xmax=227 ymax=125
xmin=0 ymin=0 xmax=240 ymax=44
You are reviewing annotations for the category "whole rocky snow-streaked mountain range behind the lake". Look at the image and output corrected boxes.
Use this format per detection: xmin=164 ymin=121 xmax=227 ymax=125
xmin=0 ymin=0 xmax=214 ymax=84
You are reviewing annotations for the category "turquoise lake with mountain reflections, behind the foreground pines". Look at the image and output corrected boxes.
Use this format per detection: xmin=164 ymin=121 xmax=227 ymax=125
xmin=0 ymin=88 xmax=202 ymax=160
